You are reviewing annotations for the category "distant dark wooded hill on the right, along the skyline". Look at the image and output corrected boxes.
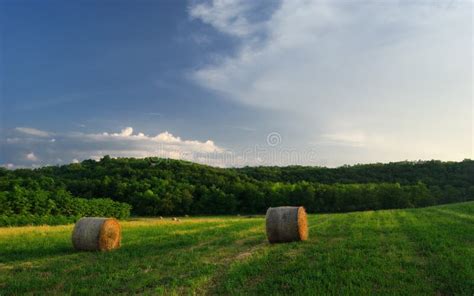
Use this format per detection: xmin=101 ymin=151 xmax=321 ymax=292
xmin=236 ymin=159 xmax=474 ymax=187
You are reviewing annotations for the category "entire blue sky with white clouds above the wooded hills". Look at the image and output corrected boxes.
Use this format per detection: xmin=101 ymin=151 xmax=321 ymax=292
xmin=0 ymin=0 xmax=474 ymax=169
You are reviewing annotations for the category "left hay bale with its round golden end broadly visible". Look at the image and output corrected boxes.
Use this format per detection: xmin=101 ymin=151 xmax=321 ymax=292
xmin=72 ymin=217 xmax=122 ymax=251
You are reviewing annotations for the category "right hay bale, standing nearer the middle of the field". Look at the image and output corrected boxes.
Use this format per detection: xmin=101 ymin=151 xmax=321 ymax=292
xmin=265 ymin=207 xmax=308 ymax=243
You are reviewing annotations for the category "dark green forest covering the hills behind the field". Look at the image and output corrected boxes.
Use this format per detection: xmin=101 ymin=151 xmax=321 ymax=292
xmin=0 ymin=156 xmax=474 ymax=225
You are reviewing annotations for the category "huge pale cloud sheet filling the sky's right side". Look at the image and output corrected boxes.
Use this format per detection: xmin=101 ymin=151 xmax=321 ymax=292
xmin=190 ymin=0 xmax=473 ymax=164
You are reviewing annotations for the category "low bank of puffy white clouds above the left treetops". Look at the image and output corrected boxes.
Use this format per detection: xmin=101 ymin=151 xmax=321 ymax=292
xmin=4 ymin=127 xmax=227 ymax=166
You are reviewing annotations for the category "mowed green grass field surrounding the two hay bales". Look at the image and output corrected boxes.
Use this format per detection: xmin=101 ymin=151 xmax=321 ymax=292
xmin=0 ymin=202 xmax=474 ymax=295
